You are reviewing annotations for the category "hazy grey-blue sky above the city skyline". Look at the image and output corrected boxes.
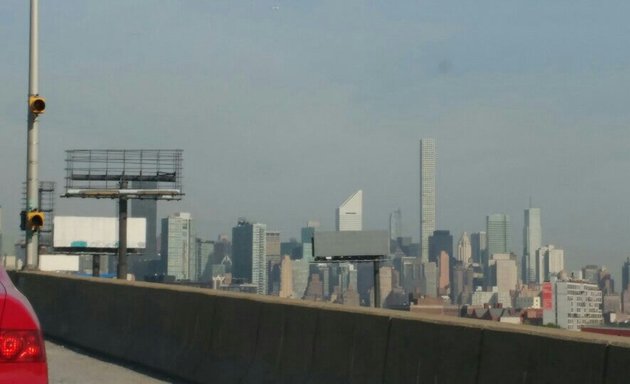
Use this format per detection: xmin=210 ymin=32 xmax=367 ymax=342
xmin=0 ymin=0 xmax=630 ymax=276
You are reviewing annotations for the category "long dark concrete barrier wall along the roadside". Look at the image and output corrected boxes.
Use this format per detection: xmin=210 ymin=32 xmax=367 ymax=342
xmin=13 ymin=272 xmax=630 ymax=384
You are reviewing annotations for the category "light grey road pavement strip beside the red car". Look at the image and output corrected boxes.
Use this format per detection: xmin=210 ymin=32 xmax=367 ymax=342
xmin=46 ymin=340 xmax=185 ymax=384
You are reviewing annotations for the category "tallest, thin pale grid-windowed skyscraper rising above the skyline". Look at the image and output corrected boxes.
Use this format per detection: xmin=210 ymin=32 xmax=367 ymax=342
xmin=420 ymin=139 xmax=436 ymax=262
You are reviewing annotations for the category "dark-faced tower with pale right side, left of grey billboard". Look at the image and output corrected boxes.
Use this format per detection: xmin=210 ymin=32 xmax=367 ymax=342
xmin=232 ymin=218 xmax=268 ymax=295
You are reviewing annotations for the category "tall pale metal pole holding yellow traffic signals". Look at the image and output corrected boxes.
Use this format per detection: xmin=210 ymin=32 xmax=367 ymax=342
xmin=25 ymin=0 xmax=43 ymax=269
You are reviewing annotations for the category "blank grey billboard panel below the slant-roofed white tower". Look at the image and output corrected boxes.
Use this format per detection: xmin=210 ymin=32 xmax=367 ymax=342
xmin=313 ymin=231 xmax=389 ymax=259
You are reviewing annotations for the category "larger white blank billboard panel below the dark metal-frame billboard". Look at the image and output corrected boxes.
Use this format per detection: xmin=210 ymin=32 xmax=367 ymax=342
xmin=53 ymin=216 xmax=146 ymax=250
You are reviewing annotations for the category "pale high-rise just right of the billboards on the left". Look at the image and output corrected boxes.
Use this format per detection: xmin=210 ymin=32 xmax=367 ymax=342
xmin=161 ymin=212 xmax=196 ymax=280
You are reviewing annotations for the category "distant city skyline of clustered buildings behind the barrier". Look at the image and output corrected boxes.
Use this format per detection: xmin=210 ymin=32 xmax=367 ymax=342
xmin=11 ymin=139 xmax=630 ymax=331
